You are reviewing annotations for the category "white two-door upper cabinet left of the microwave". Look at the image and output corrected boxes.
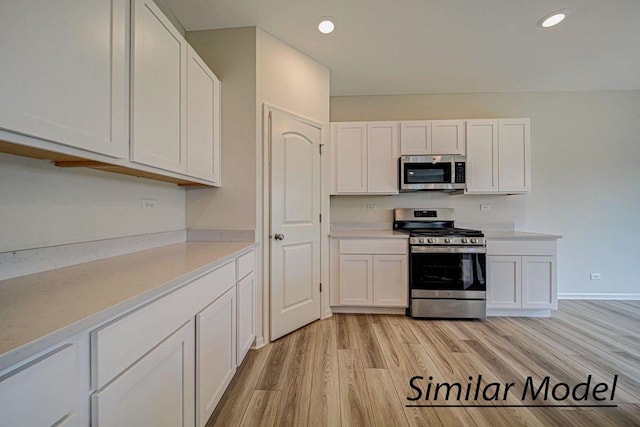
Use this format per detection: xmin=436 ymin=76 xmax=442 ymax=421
xmin=332 ymin=122 xmax=399 ymax=194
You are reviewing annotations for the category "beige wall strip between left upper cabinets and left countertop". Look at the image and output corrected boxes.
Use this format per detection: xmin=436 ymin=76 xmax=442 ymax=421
xmin=0 ymin=154 xmax=185 ymax=252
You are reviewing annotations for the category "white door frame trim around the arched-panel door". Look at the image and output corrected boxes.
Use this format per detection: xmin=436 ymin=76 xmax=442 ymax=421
xmin=256 ymin=102 xmax=332 ymax=348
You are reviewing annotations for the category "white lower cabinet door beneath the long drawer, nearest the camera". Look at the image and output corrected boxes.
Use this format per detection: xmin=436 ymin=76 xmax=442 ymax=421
xmin=91 ymin=321 xmax=195 ymax=427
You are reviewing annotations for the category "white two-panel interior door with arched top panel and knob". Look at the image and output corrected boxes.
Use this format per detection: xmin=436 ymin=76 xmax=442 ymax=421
xmin=270 ymin=111 xmax=320 ymax=339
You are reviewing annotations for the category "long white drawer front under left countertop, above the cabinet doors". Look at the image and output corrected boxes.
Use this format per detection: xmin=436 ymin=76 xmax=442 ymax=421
xmin=91 ymin=262 xmax=236 ymax=388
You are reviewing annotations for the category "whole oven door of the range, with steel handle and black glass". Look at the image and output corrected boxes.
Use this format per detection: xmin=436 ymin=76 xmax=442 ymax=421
xmin=409 ymin=246 xmax=487 ymax=299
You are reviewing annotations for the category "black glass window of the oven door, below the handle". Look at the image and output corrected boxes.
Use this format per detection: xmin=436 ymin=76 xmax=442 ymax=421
xmin=411 ymin=253 xmax=487 ymax=291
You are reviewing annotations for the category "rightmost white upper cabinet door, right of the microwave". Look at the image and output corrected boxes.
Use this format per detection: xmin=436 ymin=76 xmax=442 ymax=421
xmin=498 ymin=119 xmax=531 ymax=193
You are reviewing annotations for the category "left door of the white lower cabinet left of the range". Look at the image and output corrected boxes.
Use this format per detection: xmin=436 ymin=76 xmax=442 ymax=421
xmin=340 ymin=255 xmax=373 ymax=305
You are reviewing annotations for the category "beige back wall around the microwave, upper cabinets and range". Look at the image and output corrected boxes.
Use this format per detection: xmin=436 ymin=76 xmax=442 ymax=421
xmin=331 ymin=91 xmax=640 ymax=295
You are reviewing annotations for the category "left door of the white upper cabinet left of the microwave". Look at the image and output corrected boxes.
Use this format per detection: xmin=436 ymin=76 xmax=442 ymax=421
xmin=333 ymin=123 xmax=368 ymax=193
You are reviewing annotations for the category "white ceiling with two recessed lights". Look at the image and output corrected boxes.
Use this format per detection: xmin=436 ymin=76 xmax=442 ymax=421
xmin=165 ymin=0 xmax=640 ymax=95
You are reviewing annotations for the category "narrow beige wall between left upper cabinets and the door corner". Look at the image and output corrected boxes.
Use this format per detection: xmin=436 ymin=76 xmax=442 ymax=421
xmin=187 ymin=27 xmax=256 ymax=230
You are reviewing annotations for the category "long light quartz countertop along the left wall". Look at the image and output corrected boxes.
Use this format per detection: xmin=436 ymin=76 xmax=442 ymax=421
xmin=0 ymin=242 xmax=255 ymax=371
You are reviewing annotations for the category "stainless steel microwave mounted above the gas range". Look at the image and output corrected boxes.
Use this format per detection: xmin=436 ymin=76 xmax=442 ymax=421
xmin=399 ymin=156 xmax=466 ymax=193
